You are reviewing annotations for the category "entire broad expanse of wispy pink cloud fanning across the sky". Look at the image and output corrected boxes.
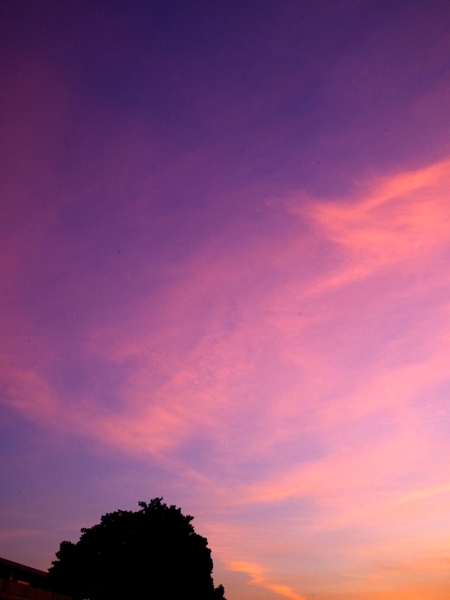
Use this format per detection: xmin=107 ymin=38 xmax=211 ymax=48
xmin=3 ymin=157 xmax=450 ymax=600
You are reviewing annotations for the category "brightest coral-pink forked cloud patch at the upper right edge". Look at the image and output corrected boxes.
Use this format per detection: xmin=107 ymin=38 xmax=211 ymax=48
xmin=285 ymin=161 xmax=450 ymax=293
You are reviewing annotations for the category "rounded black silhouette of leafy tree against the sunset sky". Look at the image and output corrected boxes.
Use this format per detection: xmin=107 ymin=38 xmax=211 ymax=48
xmin=48 ymin=498 xmax=225 ymax=600
